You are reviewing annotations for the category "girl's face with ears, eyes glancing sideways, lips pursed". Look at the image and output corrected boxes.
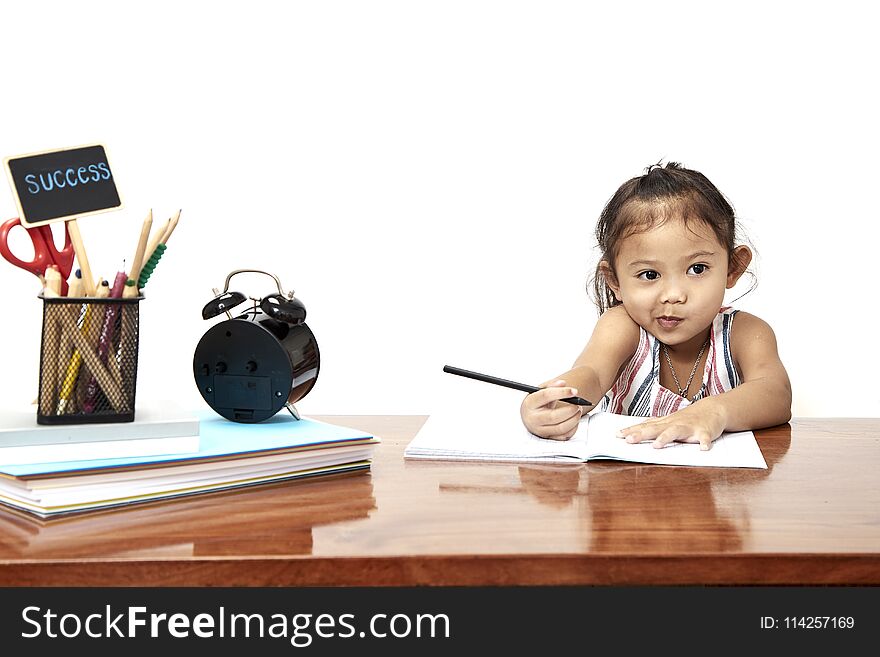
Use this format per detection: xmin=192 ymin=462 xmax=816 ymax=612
xmin=606 ymin=218 xmax=751 ymax=350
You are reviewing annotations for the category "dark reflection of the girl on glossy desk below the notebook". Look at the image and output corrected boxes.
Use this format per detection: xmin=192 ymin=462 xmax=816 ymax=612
xmin=440 ymin=425 xmax=791 ymax=554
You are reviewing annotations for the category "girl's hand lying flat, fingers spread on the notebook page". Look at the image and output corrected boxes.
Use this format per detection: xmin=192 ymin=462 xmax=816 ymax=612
xmin=617 ymin=403 xmax=725 ymax=450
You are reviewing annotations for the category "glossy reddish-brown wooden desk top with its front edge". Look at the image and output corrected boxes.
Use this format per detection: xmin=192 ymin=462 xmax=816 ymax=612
xmin=0 ymin=416 xmax=880 ymax=586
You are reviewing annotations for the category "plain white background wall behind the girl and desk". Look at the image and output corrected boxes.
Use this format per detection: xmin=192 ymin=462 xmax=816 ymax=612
xmin=0 ymin=0 xmax=880 ymax=416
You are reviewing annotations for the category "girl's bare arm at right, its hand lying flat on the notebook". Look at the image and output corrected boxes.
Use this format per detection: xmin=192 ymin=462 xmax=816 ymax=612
xmin=621 ymin=312 xmax=791 ymax=449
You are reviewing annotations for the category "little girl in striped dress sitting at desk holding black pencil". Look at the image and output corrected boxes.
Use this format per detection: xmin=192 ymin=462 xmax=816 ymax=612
xmin=520 ymin=162 xmax=791 ymax=450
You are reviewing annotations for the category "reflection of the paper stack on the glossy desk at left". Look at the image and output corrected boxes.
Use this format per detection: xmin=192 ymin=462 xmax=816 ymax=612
xmin=0 ymin=473 xmax=376 ymax=559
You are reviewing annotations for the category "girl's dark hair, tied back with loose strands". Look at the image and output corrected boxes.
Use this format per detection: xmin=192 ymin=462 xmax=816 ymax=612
xmin=587 ymin=162 xmax=748 ymax=315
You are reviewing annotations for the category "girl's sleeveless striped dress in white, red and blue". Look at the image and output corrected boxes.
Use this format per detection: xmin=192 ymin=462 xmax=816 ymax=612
xmin=599 ymin=308 xmax=740 ymax=417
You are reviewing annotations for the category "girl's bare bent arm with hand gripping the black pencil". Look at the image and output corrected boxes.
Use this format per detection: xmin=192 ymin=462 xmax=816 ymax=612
xmin=520 ymin=306 xmax=639 ymax=440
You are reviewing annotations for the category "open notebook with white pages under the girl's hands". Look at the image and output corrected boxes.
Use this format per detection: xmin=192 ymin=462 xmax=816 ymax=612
xmin=404 ymin=401 xmax=767 ymax=468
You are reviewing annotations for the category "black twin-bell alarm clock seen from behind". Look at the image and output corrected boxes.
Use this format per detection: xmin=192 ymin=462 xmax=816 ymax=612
xmin=193 ymin=269 xmax=321 ymax=422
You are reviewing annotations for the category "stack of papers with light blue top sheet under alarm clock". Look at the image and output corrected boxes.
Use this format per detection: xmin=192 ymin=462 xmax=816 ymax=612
xmin=0 ymin=412 xmax=379 ymax=517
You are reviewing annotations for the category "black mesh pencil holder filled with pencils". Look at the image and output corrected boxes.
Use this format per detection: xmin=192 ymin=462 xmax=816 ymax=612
xmin=37 ymin=297 xmax=143 ymax=424
